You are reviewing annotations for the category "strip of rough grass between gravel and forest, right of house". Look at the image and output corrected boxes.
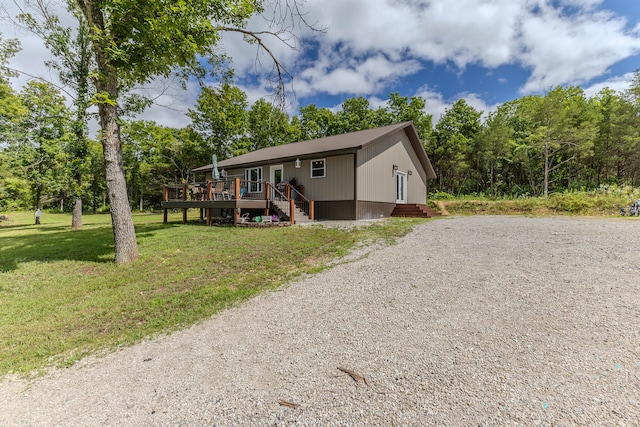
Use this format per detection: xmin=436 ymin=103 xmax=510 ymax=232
xmin=431 ymin=191 xmax=640 ymax=216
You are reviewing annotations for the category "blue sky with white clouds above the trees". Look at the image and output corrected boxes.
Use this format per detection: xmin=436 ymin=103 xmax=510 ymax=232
xmin=4 ymin=0 xmax=640 ymax=127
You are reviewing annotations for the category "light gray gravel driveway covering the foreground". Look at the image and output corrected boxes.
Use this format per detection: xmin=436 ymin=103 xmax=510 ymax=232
xmin=0 ymin=217 xmax=640 ymax=426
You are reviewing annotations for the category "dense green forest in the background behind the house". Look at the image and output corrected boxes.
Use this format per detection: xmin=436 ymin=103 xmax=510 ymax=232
xmin=0 ymin=73 xmax=640 ymax=216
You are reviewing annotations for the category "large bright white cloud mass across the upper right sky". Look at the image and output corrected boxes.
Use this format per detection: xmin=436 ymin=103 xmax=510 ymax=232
xmin=266 ymin=0 xmax=640 ymax=100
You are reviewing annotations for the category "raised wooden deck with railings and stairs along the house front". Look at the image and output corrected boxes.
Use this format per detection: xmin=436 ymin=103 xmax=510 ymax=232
xmin=162 ymin=178 xmax=314 ymax=226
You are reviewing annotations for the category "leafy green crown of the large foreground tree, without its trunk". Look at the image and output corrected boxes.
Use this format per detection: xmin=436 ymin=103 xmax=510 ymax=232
xmin=77 ymin=0 xmax=261 ymax=83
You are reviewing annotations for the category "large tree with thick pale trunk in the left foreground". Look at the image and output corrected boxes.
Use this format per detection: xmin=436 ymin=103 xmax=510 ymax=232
xmin=69 ymin=0 xmax=312 ymax=263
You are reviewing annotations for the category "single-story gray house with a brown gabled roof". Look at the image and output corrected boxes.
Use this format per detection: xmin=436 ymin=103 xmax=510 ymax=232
xmin=185 ymin=122 xmax=436 ymax=220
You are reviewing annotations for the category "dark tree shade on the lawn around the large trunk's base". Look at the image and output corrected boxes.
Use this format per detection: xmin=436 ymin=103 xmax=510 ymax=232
xmin=0 ymin=223 xmax=175 ymax=273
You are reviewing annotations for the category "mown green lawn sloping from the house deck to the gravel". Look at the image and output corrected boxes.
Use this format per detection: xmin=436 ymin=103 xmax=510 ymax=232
xmin=0 ymin=213 xmax=420 ymax=376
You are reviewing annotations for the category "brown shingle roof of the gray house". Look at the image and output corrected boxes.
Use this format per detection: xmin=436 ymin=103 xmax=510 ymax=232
xmin=194 ymin=122 xmax=435 ymax=178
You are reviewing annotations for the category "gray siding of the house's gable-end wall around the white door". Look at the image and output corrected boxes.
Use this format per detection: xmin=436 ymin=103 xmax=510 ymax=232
xmin=357 ymin=132 xmax=427 ymax=203
